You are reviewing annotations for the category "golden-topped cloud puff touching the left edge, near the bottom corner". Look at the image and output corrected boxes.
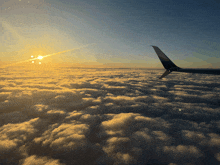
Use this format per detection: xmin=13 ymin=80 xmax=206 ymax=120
xmin=0 ymin=118 xmax=44 ymax=164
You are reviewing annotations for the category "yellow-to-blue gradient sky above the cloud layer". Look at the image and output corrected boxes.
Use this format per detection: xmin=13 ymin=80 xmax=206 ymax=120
xmin=0 ymin=0 xmax=220 ymax=68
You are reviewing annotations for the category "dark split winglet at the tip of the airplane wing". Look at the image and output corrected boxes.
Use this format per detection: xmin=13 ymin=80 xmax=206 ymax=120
xmin=152 ymin=46 xmax=180 ymax=79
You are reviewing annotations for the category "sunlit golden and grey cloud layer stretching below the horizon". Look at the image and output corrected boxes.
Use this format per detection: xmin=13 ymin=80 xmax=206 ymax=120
xmin=0 ymin=67 xmax=220 ymax=165
